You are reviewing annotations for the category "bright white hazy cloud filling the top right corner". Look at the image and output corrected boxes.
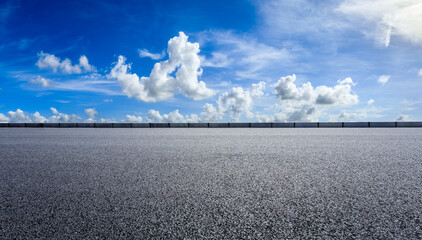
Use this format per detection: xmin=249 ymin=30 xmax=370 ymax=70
xmin=338 ymin=0 xmax=422 ymax=47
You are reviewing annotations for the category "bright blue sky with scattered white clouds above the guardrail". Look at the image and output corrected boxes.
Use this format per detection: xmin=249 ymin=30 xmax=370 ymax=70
xmin=0 ymin=0 xmax=422 ymax=122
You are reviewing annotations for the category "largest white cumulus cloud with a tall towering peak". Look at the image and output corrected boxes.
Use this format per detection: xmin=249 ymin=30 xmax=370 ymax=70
xmin=108 ymin=32 xmax=215 ymax=102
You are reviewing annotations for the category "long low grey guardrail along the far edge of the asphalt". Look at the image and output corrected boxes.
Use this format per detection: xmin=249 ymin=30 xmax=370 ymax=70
xmin=0 ymin=122 xmax=422 ymax=128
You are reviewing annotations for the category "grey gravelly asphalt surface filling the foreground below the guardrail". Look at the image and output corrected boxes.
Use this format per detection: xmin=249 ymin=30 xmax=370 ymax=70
xmin=0 ymin=128 xmax=422 ymax=239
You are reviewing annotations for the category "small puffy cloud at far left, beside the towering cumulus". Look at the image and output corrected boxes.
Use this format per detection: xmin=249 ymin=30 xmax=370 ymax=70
xmin=35 ymin=51 xmax=96 ymax=74
